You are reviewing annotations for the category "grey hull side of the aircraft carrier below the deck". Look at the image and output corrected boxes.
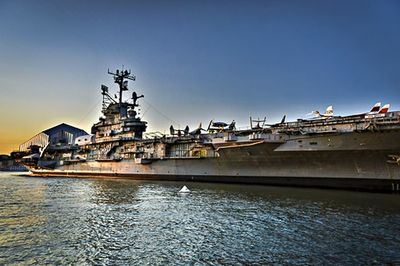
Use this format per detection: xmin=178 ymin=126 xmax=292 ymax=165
xmin=28 ymin=132 xmax=400 ymax=191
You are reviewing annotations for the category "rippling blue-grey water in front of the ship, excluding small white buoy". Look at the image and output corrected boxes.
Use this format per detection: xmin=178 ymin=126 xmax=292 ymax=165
xmin=0 ymin=173 xmax=400 ymax=265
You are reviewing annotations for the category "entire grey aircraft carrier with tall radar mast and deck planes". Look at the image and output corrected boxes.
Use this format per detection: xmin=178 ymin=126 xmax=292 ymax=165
xmin=21 ymin=70 xmax=400 ymax=192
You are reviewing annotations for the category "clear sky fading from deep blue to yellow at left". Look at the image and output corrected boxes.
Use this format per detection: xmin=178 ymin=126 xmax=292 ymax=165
xmin=0 ymin=0 xmax=400 ymax=153
